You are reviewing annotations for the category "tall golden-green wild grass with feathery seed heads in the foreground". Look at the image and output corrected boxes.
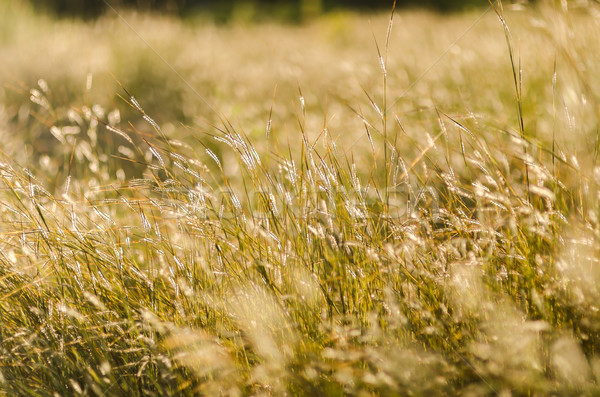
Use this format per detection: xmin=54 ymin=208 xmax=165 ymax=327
xmin=0 ymin=0 xmax=600 ymax=396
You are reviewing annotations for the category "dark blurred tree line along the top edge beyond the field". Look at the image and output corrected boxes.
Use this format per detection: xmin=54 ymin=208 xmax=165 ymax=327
xmin=30 ymin=0 xmax=487 ymax=18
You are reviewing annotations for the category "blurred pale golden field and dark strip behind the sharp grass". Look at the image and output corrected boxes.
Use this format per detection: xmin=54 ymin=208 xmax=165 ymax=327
xmin=0 ymin=0 xmax=552 ymax=184
